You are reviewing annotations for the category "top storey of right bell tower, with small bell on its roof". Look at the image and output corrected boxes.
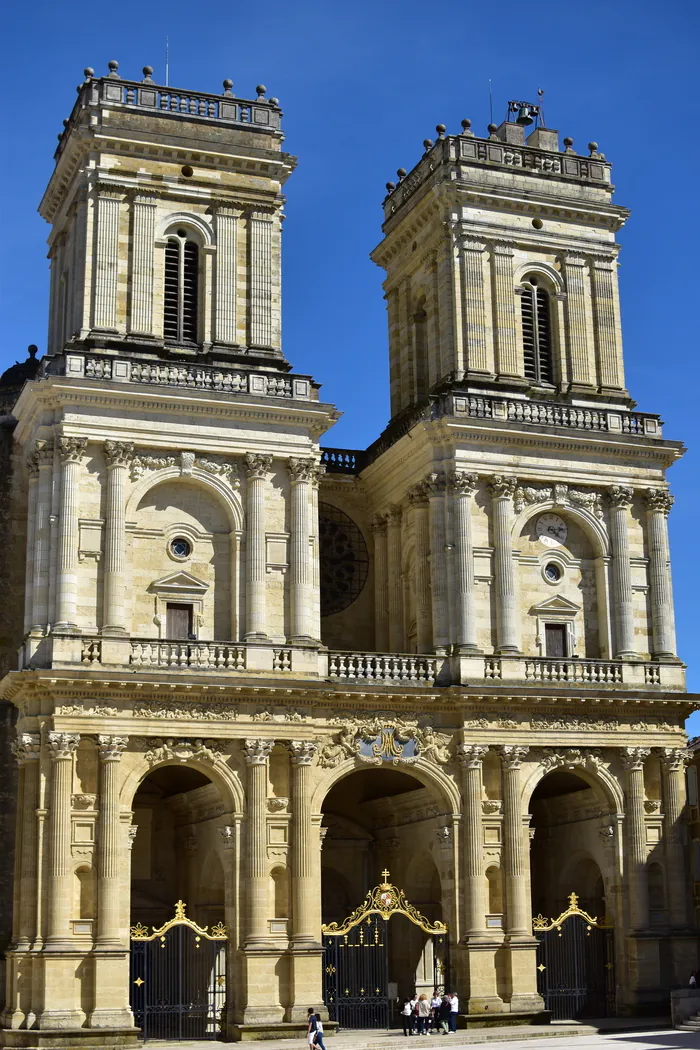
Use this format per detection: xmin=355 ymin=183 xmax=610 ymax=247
xmin=373 ymin=107 xmax=630 ymax=417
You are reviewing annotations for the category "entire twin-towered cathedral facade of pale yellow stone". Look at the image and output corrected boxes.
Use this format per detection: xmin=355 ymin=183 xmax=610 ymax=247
xmin=0 ymin=63 xmax=698 ymax=1047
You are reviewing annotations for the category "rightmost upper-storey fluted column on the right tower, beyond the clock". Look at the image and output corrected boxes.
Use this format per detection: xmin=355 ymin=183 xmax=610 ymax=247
xmin=644 ymin=488 xmax=676 ymax=659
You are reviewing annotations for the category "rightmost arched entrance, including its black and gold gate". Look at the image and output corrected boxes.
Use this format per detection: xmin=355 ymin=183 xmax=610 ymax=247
xmin=530 ymin=768 xmax=615 ymax=1021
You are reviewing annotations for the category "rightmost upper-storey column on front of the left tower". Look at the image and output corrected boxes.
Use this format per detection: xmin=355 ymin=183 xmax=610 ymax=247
xmin=289 ymin=459 xmax=321 ymax=644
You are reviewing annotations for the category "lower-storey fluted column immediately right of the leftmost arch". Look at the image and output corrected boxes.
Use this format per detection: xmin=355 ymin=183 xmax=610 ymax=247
xmin=245 ymin=740 xmax=275 ymax=948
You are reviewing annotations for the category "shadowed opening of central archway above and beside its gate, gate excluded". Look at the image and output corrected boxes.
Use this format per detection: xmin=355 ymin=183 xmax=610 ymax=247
xmin=321 ymin=767 xmax=453 ymax=1027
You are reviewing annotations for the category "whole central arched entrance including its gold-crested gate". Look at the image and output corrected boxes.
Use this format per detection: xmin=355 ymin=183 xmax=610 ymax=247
xmin=322 ymin=767 xmax=453 ymax=1028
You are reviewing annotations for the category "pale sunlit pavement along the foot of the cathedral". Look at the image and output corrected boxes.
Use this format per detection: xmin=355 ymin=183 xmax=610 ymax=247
xmin=142 ymin=1017 xmax=688 ymax=1050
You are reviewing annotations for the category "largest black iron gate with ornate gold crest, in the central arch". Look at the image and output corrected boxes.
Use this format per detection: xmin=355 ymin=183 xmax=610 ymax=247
xmin=322 ymin=869 xmax=448 ymax=1028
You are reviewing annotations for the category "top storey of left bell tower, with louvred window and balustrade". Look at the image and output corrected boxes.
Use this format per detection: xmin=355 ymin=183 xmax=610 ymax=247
xmin=40 ymin=62 xmax=296 ymax=370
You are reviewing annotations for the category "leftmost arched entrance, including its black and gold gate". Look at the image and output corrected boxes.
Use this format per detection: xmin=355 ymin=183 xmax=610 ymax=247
xmin=130 ymin=764 xmax=229 ymax=1041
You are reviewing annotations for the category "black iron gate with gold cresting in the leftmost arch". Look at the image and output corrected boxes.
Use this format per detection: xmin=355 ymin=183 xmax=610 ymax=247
xmin=130 ymin=901 xmax=228 ymax=1041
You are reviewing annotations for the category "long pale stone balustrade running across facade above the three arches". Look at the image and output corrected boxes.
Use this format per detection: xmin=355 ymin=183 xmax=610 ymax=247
xmin=19 ymin=634 xmax=685 ymax=691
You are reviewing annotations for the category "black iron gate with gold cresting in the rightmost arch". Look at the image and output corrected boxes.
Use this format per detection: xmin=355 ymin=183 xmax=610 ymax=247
xmin=532 ymin=894 xmax=615 ymax=1021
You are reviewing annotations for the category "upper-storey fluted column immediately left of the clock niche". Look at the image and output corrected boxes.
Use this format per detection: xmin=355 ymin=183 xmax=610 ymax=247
xmin=488 ymin=474 xmax=521 ymax=654
